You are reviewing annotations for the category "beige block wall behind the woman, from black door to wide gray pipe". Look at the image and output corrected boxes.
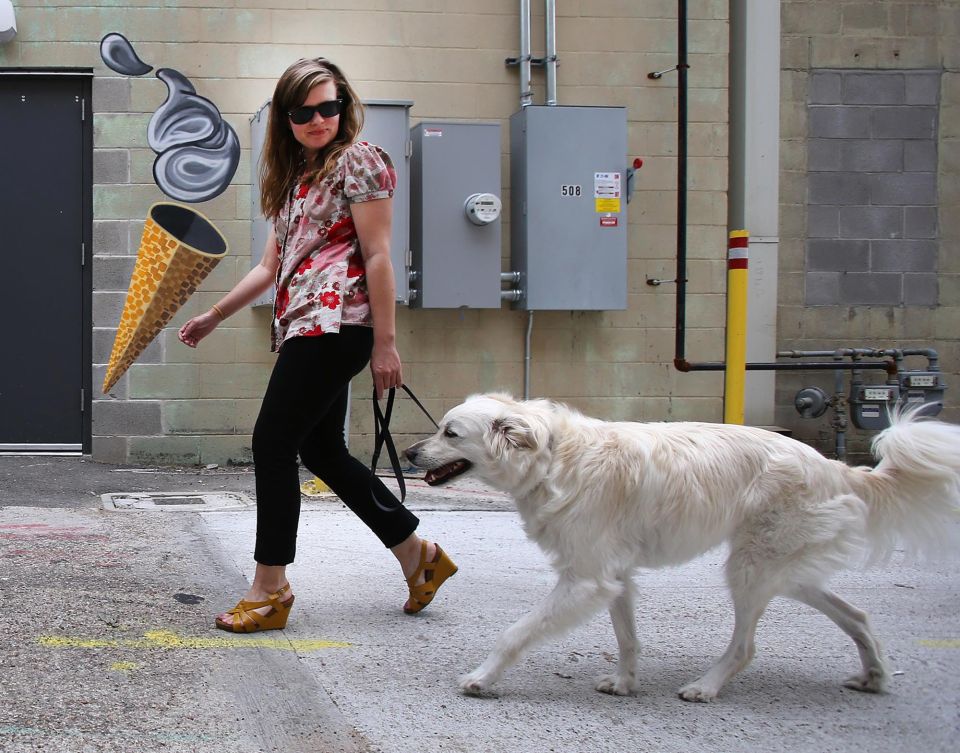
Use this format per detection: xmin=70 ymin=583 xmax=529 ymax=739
xmin=0 ymin=0 xmax=728 ymax=463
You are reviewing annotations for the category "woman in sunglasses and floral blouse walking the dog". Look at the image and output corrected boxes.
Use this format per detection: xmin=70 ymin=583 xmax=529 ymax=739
xmin=179 ymin=58 xmax=457 ymax=632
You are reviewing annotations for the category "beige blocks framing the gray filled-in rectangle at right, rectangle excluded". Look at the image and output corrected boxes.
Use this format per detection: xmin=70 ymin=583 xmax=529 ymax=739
xmin=777 ymin=0 xmax=960 ymax=458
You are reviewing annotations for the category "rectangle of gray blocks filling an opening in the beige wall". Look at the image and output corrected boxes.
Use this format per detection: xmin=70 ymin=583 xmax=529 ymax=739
xmin=805 ymin=70 xmax=940 ymax=306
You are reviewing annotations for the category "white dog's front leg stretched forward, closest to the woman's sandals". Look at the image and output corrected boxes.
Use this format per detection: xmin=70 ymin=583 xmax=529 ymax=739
xmin=460 ymin=574 xmax=618 ymax=694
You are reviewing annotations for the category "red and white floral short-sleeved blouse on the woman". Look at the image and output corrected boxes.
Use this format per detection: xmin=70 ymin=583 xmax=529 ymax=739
xmin=270 ymin=141 xmax=397 ymax=351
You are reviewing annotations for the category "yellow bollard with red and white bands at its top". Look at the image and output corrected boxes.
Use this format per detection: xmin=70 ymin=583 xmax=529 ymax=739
xmin=723 ymin=230 xmax=750 ymax=424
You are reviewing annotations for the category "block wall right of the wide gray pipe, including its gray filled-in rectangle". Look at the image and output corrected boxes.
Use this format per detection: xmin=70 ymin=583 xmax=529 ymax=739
xmin=777 ymin=0 xmax=960 ymax=459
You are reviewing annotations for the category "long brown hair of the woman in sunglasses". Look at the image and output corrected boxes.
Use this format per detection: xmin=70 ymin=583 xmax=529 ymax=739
xmin=260 ymin=58 xmax=363 ymax=219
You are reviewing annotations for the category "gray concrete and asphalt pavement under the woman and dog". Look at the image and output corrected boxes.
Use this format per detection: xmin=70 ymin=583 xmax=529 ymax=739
xmin=0 ymin=457 xmax=960 ymax=753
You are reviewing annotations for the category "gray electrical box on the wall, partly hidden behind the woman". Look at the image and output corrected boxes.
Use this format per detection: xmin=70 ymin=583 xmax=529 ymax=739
xmin=250 ymin=100 xmax=413 ymax=306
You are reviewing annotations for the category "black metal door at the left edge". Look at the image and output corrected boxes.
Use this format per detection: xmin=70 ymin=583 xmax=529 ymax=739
xmin=0 ymin=72 xmax=91 ymax=452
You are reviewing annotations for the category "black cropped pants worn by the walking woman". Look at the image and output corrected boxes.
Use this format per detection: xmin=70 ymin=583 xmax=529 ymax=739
xmin=253 ymin=326 xmax=419 ymax=565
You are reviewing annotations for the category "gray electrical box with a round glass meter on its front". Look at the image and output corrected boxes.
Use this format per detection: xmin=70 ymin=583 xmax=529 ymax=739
xmin=410 ymin=121 xmax=501 ymax=308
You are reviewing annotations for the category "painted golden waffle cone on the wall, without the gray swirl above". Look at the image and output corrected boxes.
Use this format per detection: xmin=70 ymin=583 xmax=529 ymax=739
xmin=103 ymin=202 xmax=227 ymax=394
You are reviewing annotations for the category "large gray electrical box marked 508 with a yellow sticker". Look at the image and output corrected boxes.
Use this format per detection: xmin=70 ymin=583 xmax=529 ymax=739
xmin=510 ymin=105 xmax=627 ymax=311
